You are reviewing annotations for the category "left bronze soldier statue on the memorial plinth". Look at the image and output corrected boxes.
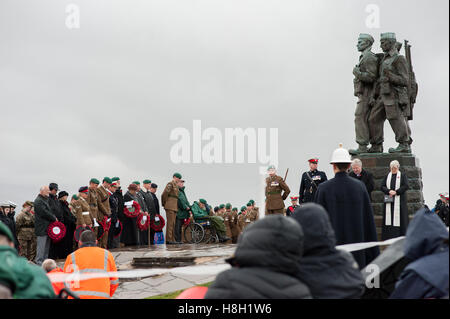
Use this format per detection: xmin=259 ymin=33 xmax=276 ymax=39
xmin=349 ymin=33 xmax=378 ymax=155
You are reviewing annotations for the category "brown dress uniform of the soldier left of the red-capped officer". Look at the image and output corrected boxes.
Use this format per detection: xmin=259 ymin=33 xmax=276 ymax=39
xmin=265 ymin=175 xmax=291 ymax=215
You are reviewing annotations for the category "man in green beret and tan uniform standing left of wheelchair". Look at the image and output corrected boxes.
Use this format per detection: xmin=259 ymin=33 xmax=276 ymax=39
xmin=161 ymin=173 xmax=181 ymax=245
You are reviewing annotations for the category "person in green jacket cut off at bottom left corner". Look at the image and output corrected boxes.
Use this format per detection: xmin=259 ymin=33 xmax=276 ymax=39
xmin=0 ymin=222 xmax=55 ymax=299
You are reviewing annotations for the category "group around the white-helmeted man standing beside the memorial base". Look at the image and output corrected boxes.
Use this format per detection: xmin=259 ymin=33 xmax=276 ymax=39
xmin=265 ymin=145 xmax=418 ymax=268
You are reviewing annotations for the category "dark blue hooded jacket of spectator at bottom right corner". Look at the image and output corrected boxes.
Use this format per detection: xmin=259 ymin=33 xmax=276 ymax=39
xmin=390 ymin=208 xmax=449 ymax=299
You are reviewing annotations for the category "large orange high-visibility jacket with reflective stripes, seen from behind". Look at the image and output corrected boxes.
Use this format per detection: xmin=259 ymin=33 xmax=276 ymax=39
xmin=64 ymin=247 xmax=119 ymax=299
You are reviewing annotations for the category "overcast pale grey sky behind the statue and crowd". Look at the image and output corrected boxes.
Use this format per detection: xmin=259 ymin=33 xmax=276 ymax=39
xmin=0 ymin=0 xmax=449 ymax=214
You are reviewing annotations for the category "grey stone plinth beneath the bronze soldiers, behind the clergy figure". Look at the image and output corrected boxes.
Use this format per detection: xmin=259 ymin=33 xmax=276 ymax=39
xmin=352 ymin=153 xmax=424 ymax=239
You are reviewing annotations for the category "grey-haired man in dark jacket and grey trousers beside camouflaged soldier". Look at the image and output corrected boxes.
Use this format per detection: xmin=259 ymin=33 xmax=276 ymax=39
xmin=34 ymin=186 xmax=58 ymax=265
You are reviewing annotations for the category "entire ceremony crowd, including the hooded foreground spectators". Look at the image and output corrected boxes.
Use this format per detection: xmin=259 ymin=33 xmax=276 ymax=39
xmin=0 ymin=145 xmax=449 ymax=298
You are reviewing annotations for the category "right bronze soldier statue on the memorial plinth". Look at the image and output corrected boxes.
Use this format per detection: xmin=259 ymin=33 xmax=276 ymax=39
xmin=369 ymin=32 xmax=411 ymax=153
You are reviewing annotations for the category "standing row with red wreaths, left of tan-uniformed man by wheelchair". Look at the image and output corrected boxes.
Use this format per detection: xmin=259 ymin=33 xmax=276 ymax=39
xmin=0 ymin=177 xmax=159 ymax=265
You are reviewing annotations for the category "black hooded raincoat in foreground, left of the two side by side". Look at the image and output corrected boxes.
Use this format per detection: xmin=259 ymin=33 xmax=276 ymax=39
xmin=205 ymin=215 xmax=311 ymax=299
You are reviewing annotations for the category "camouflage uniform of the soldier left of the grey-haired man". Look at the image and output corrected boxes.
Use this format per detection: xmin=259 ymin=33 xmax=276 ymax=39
xmin=16 ymin=211 xmax=36 ymax=261
